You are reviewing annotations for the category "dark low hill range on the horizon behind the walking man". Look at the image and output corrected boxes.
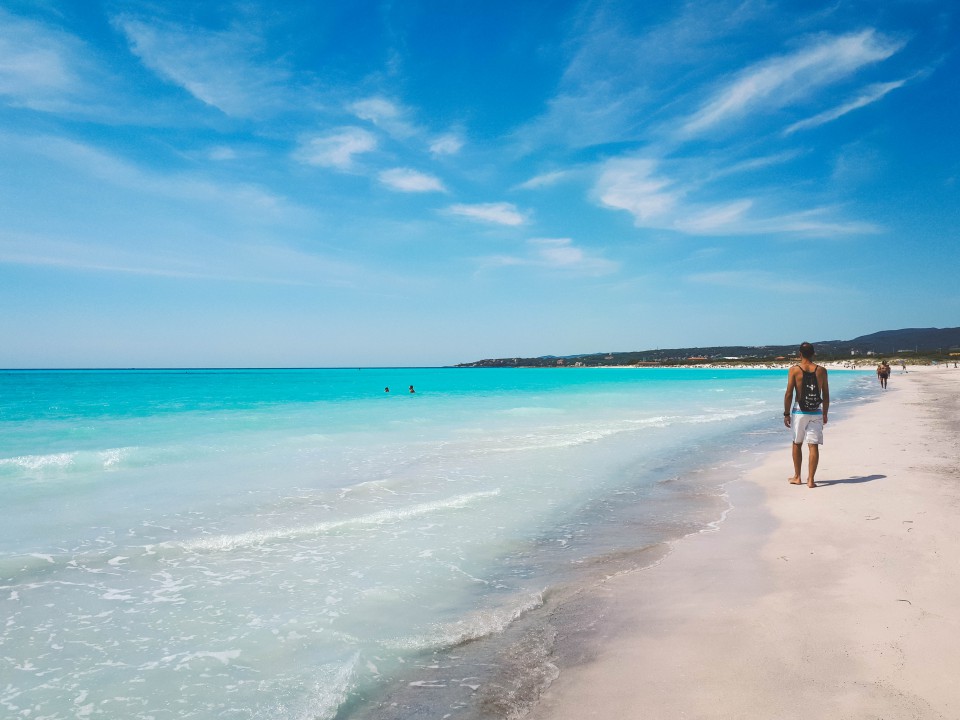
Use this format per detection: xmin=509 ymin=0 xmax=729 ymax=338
xmin=456 ymin=327 xmax=960 ymax=367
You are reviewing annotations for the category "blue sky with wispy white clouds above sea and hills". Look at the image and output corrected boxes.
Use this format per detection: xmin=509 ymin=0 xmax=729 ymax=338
xmin=0 ymin=0 xmax=960 ymax=367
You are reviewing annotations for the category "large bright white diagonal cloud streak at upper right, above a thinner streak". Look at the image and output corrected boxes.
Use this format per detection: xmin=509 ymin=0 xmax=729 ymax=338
xmin=682 ymin=30 xmax=903 ymax=135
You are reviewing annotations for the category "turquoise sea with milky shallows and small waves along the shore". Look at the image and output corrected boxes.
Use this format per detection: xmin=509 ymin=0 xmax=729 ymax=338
xmin=0 ymin=368 xmax=870 ymax=720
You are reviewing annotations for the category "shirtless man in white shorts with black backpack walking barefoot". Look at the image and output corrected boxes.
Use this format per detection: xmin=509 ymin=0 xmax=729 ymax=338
xmin=783 ymin=342 xmax=830 ymax=487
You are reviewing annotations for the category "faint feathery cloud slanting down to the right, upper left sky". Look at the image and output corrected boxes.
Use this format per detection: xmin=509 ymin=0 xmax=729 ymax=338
xmin=114 ymin=15 xmax=290 ymax=117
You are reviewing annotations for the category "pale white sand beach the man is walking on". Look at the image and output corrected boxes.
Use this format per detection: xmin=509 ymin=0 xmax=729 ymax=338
xmin=529 ymin=367 xmax=960 ymax=720
